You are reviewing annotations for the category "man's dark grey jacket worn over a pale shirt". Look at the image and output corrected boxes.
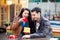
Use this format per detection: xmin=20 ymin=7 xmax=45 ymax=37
xmin=30 ymin=17 xmax=52 ymax=38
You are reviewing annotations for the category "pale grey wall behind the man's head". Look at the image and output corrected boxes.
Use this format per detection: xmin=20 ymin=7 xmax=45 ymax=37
xmin=28 ymin=2 xmax=60 ymax=15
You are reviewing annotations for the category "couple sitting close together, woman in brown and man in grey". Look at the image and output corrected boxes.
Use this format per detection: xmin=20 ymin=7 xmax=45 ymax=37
xmin=11 ymin=7 xmax=52 ymax=38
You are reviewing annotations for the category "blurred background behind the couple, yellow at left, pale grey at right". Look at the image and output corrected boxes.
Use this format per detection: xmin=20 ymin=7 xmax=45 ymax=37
xmin=0 ymin=0 xmax=60 ymax=37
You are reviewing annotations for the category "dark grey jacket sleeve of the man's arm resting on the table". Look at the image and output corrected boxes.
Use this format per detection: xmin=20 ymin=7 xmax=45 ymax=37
xmin=30 ymin=21 xmax=52 ymax=38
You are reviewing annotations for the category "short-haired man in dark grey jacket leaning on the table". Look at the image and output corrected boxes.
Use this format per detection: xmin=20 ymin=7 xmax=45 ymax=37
xmin=22 ymin=7 xmax=52 ymax=38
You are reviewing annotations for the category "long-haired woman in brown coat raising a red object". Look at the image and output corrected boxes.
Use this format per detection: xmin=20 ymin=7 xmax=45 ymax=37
xmin=11 ymin=8 xmax=32 ymax=35
